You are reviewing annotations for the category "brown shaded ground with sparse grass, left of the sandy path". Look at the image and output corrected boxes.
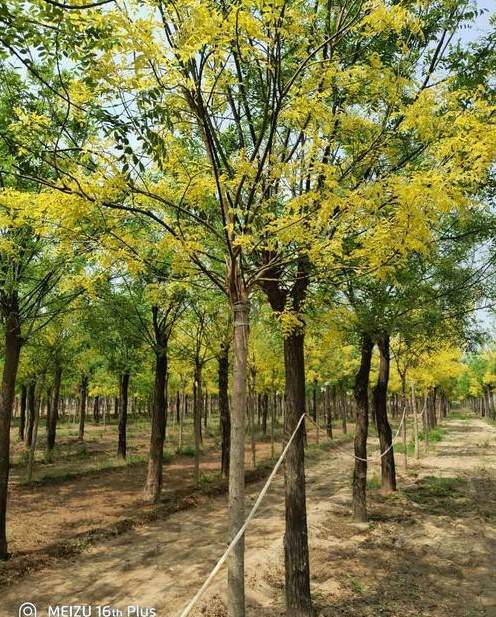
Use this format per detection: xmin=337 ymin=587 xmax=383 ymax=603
xmin=7 ymin=424 xmax=290 ymax=557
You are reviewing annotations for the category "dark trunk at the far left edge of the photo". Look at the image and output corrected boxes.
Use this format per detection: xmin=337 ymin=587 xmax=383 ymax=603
xmin=0 ymin=313 xmax=21 ymax=560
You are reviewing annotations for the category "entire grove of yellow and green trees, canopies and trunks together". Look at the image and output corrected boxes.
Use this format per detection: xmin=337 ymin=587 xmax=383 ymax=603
xmin=0 ymin=0 xmax=496 ymax=617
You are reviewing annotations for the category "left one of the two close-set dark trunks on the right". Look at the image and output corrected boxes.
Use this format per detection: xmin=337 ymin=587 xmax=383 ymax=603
xmin=353 ymin=334 xmax=374 ymax=522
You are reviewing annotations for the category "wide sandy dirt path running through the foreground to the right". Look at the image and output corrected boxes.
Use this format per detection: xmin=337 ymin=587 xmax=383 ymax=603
xmin=0 ymin=416 xmax=496 ymax=617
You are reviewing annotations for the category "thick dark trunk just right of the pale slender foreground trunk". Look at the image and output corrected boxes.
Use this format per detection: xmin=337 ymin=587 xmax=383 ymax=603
xmin=284 ymin=332 xmax=314 ymax=617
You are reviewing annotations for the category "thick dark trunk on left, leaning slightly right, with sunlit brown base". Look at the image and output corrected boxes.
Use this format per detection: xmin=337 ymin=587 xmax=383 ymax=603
xmin=144 ymin=347 xmax=167 ymax=503
